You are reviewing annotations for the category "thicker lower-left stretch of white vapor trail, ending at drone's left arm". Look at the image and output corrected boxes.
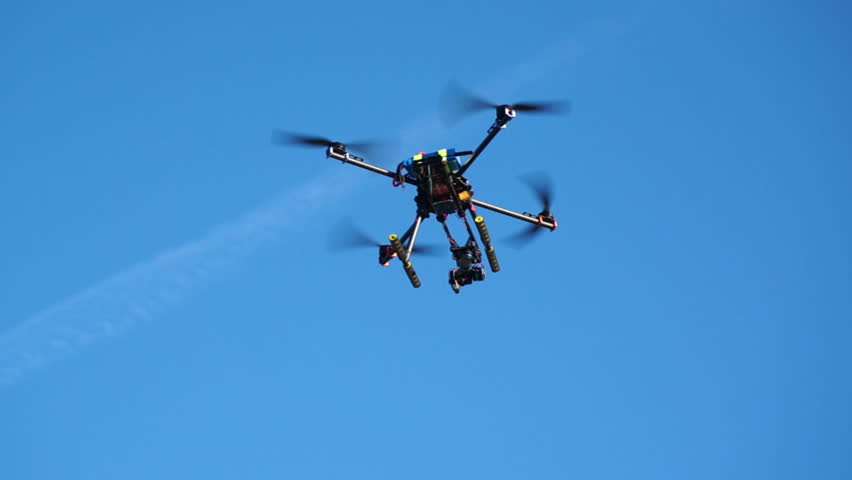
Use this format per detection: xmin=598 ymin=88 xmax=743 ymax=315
xmin=0 ymin=171 xmax=356 ymax=385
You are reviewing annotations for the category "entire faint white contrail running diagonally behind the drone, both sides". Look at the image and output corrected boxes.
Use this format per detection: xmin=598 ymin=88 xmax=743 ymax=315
xmin=0 ymin=16 xmax=630 ymax=386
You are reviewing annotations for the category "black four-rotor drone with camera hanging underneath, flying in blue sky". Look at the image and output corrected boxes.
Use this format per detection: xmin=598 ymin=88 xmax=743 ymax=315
xmin=274 ymin=86 xmax=566 ymax=293
